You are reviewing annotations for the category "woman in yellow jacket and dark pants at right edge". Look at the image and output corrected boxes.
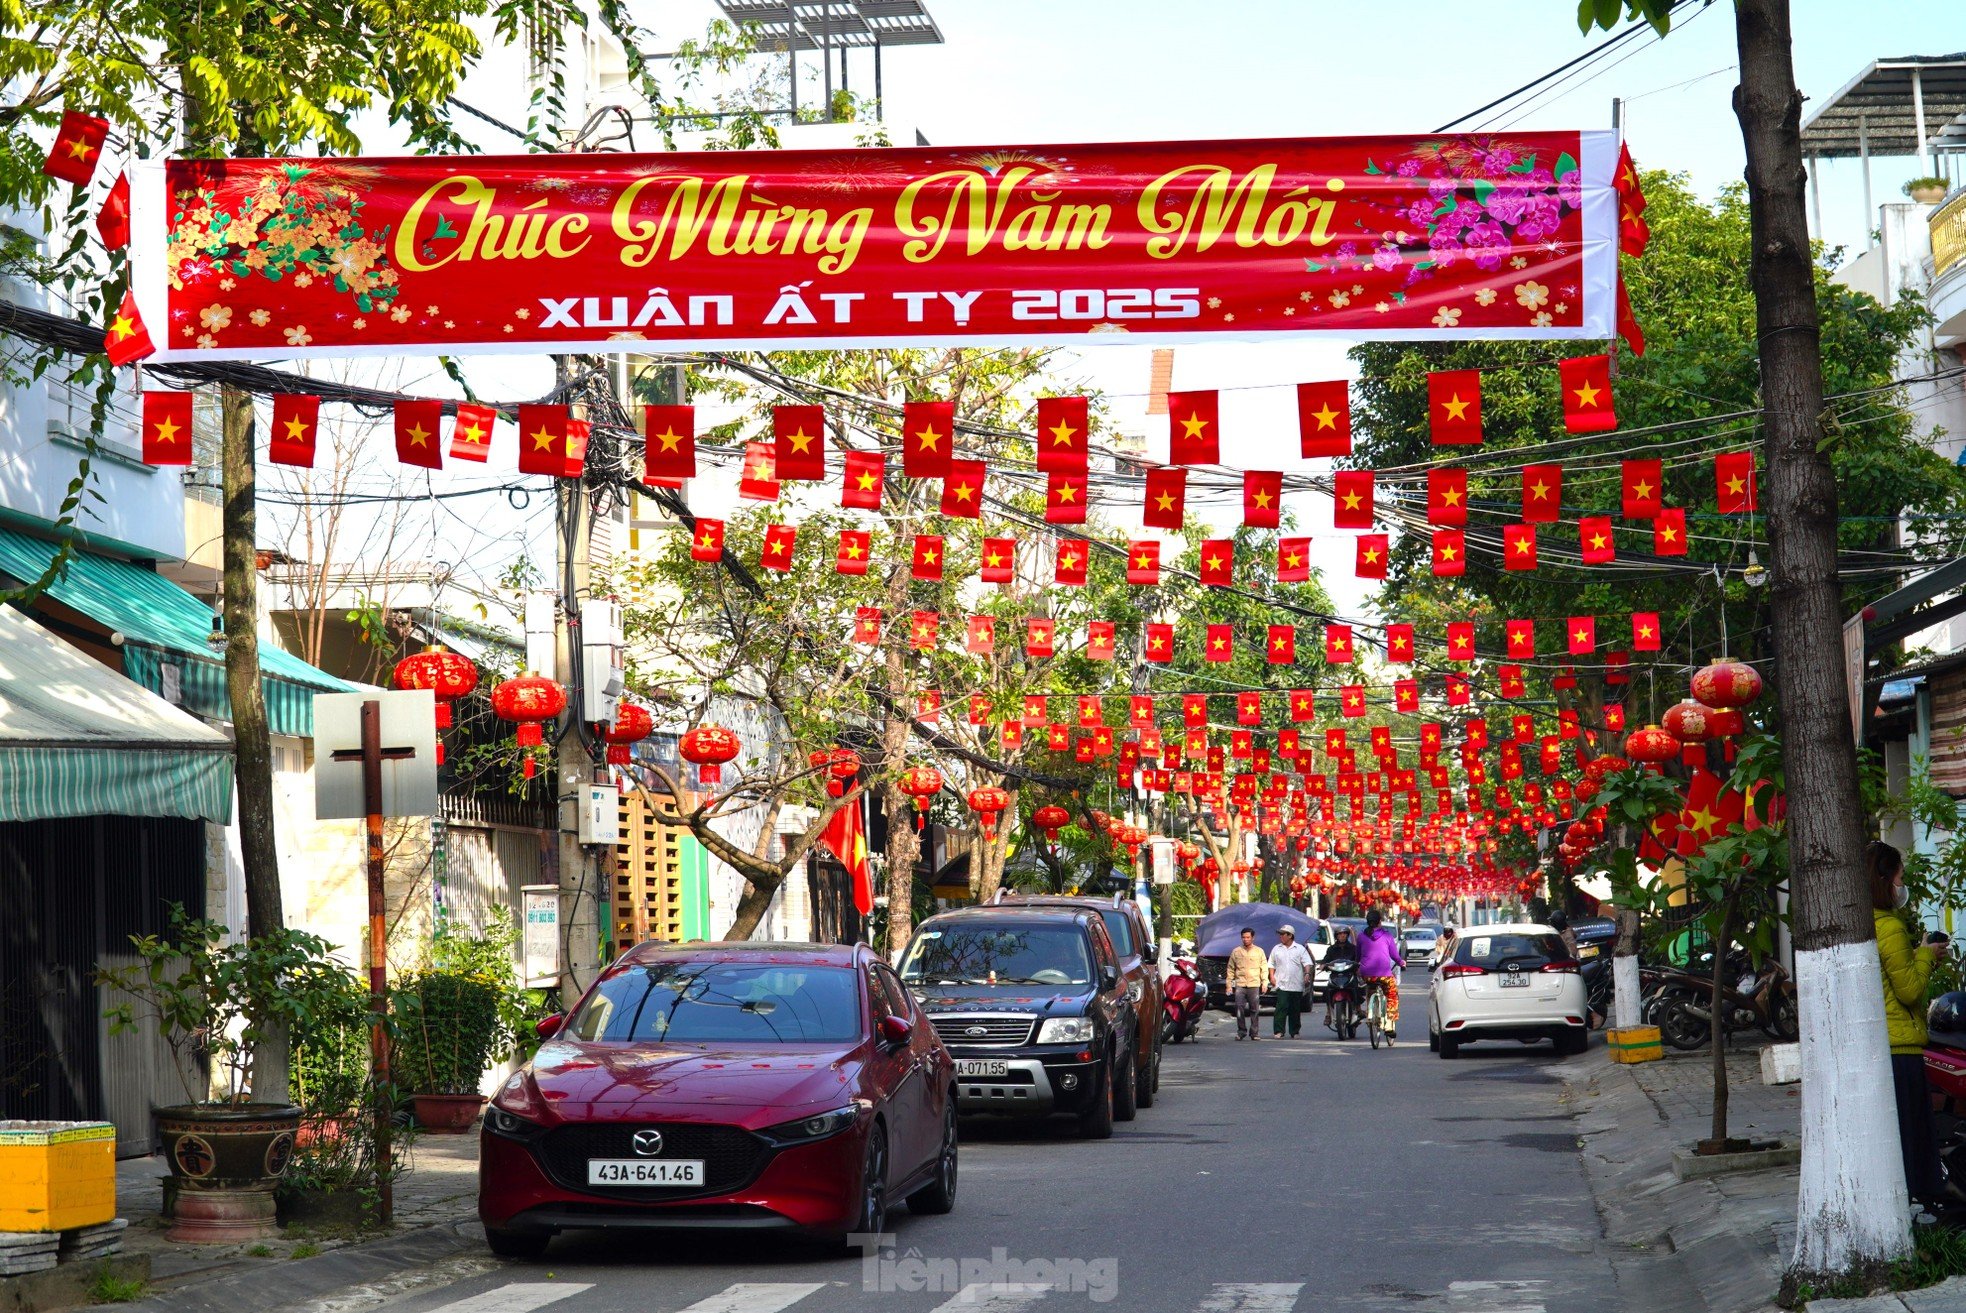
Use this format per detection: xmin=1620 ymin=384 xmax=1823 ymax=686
xmin=1864 ymin=843 xmax=1966 ymax=1203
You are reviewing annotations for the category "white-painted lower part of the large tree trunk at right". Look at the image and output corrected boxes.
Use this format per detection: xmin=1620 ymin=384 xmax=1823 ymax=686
xmin=1793 ymin=940 xmax=1911 ymax=1272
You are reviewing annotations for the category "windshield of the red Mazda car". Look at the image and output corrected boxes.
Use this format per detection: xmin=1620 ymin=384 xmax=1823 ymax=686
xmin=566 ymin=961 xmax=861 ymax=1044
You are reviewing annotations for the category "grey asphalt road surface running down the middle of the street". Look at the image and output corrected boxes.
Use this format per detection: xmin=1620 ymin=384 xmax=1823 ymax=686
xmin=346 ymin=971 xmax=1616 ymax=1313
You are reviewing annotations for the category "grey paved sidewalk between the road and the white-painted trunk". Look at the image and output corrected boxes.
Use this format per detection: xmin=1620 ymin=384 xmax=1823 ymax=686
xmin=1559 ymin=1044 xmax=1801 ymax=1313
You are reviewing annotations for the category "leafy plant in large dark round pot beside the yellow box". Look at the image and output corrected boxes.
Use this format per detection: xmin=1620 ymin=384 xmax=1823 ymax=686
xmin=96 ymin=908 xmax=348 ymax=1244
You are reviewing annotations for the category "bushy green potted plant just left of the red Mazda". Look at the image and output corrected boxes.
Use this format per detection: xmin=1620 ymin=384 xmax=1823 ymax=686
xmin=389 ymin=967 xmax=511 ymax=1134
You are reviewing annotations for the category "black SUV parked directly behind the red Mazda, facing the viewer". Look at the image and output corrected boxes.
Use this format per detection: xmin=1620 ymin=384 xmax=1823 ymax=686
xmin=900 ymin=906 xmax=1140 ymax=1140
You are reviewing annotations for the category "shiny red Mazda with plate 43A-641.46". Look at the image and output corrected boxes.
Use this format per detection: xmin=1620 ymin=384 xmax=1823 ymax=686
xmin=478 ymin=943 xmax=955 ymax=1258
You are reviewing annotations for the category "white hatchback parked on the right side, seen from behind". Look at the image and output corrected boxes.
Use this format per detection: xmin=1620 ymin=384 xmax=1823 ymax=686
xmin=1427 ymin=922 xmax=1590 ymax=1057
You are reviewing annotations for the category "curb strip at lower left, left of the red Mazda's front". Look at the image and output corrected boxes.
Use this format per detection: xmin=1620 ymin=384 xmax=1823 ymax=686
xmin=122 ymin=1221 xmax=484 ymax=1313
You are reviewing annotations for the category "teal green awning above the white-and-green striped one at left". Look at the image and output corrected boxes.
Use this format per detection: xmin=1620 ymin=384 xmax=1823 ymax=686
xmin=0 ymin=529 xmax=358 ymax=737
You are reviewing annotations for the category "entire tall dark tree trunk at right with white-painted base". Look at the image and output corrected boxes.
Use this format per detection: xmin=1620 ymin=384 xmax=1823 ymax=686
xmin=1734 ymin=0 xmax=1911 ymax=1280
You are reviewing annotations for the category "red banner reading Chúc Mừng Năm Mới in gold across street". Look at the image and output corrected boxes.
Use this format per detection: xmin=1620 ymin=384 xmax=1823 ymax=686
xmin=132 ymin=132 xmax=1618 ymax=360
